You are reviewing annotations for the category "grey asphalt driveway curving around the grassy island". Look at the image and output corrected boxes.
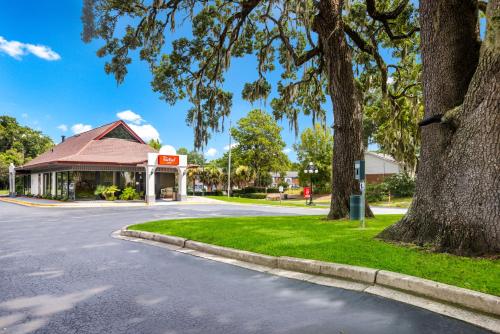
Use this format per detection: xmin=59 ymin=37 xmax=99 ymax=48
xmin=0 ymin=202 xmax=485 ymax=334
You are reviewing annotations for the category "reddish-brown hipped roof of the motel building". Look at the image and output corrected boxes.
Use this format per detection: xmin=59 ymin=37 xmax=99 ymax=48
xmin=22 ymin=121 xmax=156 ymax=169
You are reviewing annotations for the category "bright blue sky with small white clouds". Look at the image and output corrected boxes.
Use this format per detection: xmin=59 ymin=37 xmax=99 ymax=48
xmin=0 ymin=0 xmax=350 ymax=160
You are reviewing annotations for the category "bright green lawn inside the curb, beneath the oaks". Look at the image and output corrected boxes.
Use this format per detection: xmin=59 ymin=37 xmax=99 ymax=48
xmin=130 ymin=215 xmax=500 ymax=296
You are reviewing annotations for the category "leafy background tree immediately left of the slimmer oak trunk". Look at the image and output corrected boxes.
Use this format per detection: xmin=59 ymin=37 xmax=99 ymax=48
xmin=293 ymin=124 xmax=333 ymax=189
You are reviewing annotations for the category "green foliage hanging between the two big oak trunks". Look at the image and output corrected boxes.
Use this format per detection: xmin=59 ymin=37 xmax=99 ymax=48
xmin=359 ymin=32 xmax=424 ymax=175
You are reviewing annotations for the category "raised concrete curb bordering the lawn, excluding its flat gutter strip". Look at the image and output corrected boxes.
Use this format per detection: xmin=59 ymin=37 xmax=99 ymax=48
xmin=120 ymin=226 xmax=500 ymax=324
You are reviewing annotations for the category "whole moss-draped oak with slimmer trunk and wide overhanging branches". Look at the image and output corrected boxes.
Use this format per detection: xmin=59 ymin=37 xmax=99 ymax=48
xmin=82 ymin=0 xmax=418 ymax=218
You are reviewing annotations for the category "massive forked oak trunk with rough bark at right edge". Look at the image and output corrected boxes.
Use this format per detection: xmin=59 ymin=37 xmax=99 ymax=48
xmin=380 ymin=0 xmax=500 ymax=255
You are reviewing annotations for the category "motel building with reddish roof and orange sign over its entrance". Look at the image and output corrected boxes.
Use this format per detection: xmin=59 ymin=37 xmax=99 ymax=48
xmin=9 ymin=121 xmax=187 ymax=204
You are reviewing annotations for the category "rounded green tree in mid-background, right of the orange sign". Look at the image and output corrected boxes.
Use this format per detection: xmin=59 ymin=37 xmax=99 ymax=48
xmin=231 ymin=109 xmax=290 ymax=186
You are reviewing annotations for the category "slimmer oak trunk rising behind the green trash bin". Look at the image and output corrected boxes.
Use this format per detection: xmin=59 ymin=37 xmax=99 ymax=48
xmin=314 ymin=0 xmax=373 ymax=219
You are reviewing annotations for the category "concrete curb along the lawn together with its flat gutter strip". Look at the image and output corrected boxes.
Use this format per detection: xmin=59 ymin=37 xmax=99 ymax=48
xmin=117 ymin=226 xmax=500 ymax=333
